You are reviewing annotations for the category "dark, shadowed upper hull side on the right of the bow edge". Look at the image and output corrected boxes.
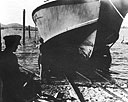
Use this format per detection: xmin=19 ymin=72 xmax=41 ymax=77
xmin=95 ymin=0 xmax=123 ymax=50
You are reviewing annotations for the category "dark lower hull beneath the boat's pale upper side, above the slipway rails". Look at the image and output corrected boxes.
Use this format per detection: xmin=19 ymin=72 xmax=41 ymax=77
xmin=42 ymin=22 xmax=111 ymax=80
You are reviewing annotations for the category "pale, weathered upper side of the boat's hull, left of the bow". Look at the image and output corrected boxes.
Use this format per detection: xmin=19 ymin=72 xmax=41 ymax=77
xmin=33 ymin=0 xmax=100 ymax=42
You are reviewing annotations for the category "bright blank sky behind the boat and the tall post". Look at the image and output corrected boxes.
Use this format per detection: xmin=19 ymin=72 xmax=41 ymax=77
xmin=0 ymin=0 xmax=128 ymax=26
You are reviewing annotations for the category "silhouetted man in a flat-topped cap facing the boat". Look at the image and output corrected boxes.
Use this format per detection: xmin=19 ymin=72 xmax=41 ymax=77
xmin=0 ymin=35 xmax=23 ymax=102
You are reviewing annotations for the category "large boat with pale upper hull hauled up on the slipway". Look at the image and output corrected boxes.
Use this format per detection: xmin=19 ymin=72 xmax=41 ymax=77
xmin=32 ymin=0 xmax=128 ymax=79
